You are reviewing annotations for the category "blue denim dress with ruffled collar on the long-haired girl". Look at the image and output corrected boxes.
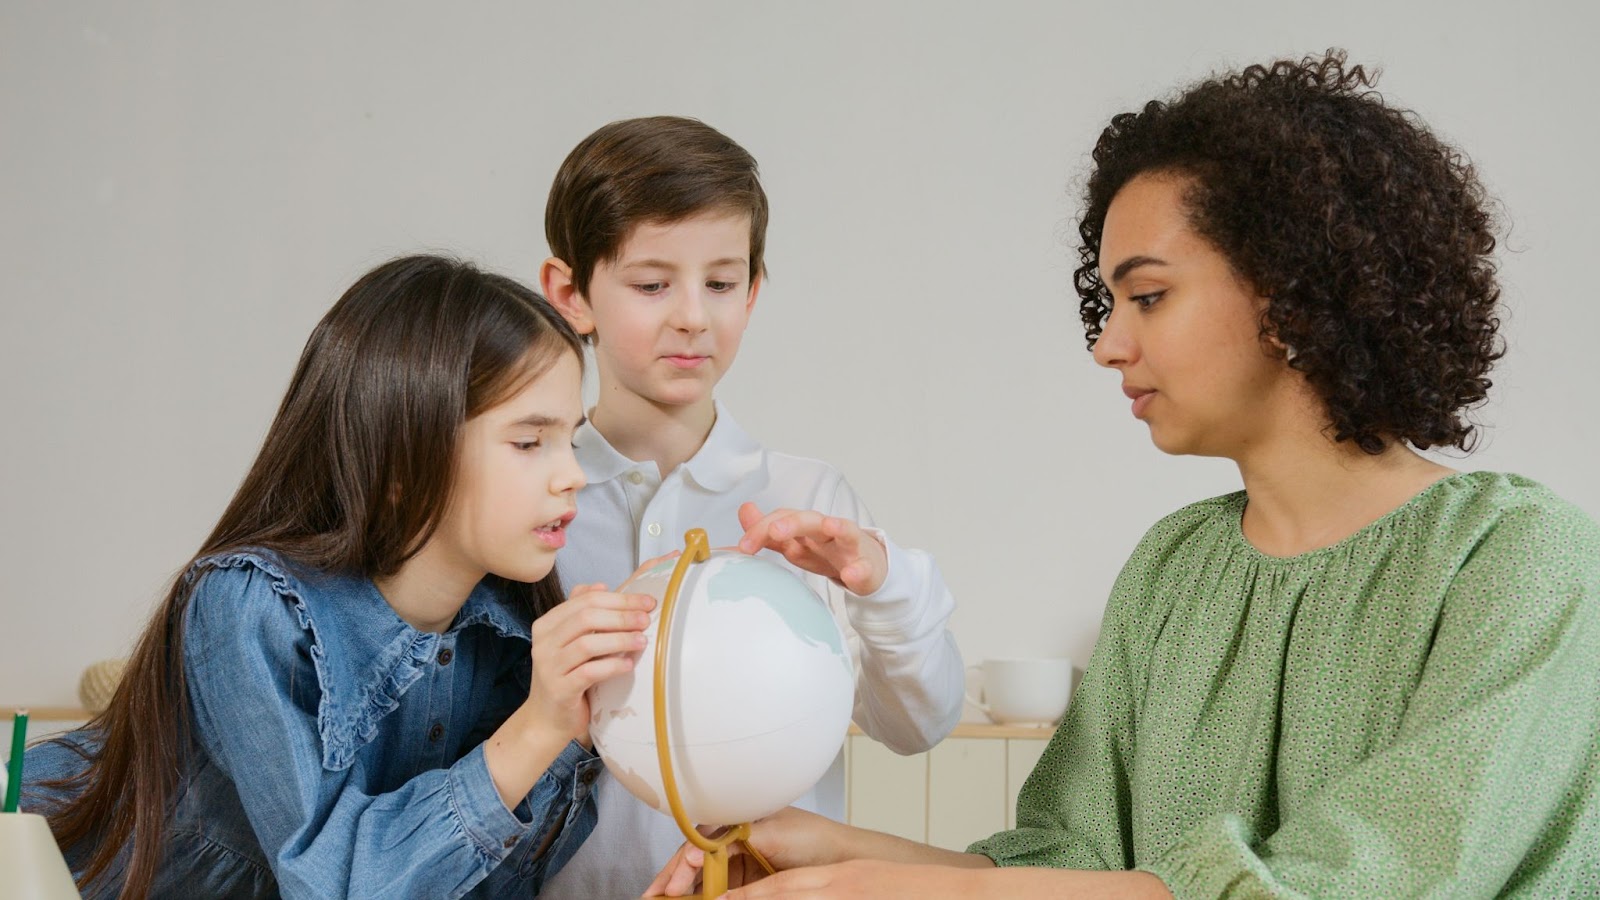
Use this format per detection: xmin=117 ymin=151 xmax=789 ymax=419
xmin=24 ymin=551 xmax=602 ymax=898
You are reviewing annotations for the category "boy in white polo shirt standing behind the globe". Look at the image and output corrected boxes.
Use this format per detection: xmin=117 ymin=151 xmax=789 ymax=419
xmin=539 ymin=117 xmax=963 ymax=900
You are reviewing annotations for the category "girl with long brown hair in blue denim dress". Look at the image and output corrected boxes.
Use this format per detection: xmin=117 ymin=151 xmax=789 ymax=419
xmin=27 ymin=256 xmax=651 ymax=898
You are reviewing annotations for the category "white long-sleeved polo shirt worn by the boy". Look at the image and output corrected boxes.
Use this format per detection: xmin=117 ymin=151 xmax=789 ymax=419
xmin=539 ymin=402 xmax=963 ymax=900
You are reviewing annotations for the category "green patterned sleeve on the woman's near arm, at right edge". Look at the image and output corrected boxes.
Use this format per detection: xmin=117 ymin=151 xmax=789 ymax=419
xmin=1141 ymin=508 xmax=1600 ymax=898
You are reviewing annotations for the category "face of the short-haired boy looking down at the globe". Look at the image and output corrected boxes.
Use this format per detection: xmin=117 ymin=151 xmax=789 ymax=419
xmin=574 ymin=211 xmax=760 ymax=407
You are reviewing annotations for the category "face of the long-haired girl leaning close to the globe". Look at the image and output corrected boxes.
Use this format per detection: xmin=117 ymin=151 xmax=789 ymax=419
xmin=429 ymin=351 xmax=584 ymax=583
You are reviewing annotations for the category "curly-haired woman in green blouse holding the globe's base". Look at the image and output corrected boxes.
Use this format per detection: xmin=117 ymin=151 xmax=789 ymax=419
xmin=653 ymin=53 xmax=1600 ymax=898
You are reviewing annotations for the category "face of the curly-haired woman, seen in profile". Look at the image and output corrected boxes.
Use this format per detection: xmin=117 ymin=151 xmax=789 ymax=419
xmin=1094 ymin=175 xmax=1304 ymax=460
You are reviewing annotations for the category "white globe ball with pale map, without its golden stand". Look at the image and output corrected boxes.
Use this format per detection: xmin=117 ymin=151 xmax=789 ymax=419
xmin=589 ymin=531 xmax=856 ymax=825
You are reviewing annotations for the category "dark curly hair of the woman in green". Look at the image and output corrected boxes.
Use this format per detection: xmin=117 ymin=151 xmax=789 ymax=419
xmin=1074 ymin=50 xmax=1504 ymax=453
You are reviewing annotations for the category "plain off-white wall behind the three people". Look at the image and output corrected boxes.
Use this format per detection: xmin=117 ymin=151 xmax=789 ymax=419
xmin=0 ymin=0 xmax=1600 ymax=705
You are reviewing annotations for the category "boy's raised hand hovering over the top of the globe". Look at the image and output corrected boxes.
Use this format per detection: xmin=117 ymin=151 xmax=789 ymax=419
xmin=739 ymin=503 xmax=890 ymax=594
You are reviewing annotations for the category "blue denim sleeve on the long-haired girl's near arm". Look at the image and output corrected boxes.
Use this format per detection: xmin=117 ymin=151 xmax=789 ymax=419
xmin=184 ymin=567 xmax=587 ymax=897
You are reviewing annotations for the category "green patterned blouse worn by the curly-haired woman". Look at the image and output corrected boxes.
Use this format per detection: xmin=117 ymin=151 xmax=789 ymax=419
xmin=970 ymin=472 xmax=1600 ymax=898
